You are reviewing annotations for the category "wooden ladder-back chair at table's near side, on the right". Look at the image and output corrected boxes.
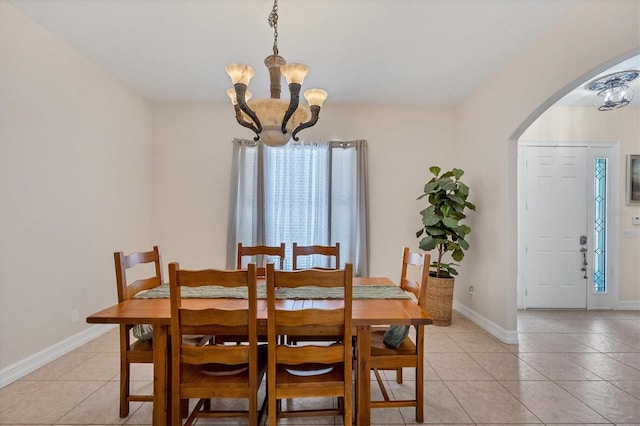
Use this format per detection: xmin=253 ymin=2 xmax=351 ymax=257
xmin=267 ymin=263 xmax=353 ymax=426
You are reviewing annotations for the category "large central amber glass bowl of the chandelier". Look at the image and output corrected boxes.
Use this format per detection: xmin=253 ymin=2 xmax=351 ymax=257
xmin=247 ymin=99 xmax=311 ymax=146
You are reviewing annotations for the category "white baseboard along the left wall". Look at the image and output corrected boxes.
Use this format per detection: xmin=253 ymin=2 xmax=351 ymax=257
xmin=0 ymin=324 xmax=117 ymax=388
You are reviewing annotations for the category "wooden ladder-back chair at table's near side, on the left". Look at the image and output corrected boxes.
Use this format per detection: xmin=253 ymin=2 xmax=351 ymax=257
xmin=169 ymin=262 xmax=267 ymax=425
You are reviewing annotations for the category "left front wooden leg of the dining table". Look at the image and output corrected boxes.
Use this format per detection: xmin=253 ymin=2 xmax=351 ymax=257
xmin=153 ymin=325 xmax=171 ymax=426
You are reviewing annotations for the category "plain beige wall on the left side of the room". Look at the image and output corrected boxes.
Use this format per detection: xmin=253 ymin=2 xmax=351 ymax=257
xmin=0 ymin=2 xmax=152 ymax=370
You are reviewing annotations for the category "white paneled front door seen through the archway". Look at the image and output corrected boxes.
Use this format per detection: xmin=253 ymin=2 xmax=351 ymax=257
xmin=522 ymin=146 xmax=589 ymax=308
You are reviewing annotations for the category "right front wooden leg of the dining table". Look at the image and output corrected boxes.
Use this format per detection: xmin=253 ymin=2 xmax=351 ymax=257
xmin=356 ymin=325 xmax=371 ymax=426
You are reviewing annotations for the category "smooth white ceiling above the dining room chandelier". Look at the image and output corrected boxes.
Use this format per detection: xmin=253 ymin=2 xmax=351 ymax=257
xmin=11 ymin=0 xmax=640 ymax=105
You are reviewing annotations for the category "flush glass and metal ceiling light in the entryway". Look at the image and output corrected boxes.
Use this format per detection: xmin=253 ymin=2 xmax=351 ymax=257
xmin=584 ymin=70 xmax=640 ymax=111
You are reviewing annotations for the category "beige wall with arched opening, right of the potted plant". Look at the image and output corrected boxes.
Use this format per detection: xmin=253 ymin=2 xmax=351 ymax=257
xmin=455 ymin=1 xmax=640 ymax=337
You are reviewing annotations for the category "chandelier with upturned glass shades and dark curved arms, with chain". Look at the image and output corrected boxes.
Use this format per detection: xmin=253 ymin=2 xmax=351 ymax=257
xmin=225 ymin=0 xmax=327 ymax=146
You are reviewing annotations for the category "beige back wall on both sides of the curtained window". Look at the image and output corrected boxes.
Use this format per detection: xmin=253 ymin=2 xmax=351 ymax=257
xmin=153 ymin=104 xmax=455 ymax=277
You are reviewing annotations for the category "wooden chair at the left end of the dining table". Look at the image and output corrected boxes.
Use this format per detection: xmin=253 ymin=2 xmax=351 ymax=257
xmin=113 ymin=246 xmax=163 ymax=417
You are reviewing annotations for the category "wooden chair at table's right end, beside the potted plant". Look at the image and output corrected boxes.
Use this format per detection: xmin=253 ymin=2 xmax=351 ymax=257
xmin=363 ymin=247 xmax=431 ymax=423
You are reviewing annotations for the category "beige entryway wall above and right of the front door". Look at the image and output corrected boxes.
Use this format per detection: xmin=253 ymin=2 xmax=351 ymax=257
xmin=520 ymin=106 xmax=640 ymax=303
